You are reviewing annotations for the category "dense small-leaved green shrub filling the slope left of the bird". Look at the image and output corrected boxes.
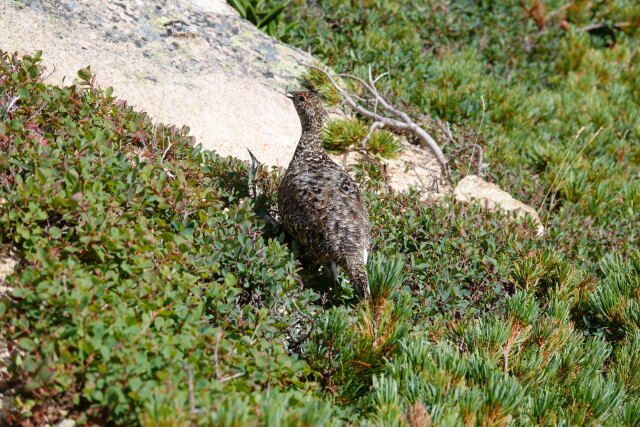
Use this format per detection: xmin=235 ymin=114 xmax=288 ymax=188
xmin=0 ymin=54 xmax=318 ymax=425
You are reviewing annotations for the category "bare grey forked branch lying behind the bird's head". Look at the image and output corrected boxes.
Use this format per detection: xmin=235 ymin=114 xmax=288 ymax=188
xmin=302 ymin=63 xmax=449 ymax=172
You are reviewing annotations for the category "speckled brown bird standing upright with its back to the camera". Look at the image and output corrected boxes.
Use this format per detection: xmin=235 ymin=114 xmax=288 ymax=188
xmin=278 ymin=92 xmax=370 ymax=297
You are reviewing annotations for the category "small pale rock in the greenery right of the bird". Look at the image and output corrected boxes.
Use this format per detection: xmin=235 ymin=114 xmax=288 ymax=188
xmin=453 ymin=175 xmax=544 ymax=236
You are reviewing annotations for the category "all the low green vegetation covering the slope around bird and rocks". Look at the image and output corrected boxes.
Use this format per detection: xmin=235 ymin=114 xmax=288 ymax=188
xmin=0 ymin=2 xmax=640 ymax=426
